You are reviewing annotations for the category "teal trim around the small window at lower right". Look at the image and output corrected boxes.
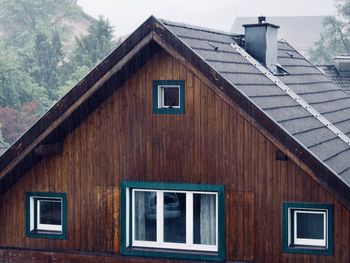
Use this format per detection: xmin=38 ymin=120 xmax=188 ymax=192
xmin=282 ymin=202 xmax=334 ymax=256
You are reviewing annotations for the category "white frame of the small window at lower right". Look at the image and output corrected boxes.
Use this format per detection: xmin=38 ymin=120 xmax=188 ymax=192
xmin=288 ymin=208 xmax=328 ymax=247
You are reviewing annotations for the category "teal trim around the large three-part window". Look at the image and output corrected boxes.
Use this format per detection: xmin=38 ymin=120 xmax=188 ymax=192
xmin=120 ymin=181 xmax=226 ymax=261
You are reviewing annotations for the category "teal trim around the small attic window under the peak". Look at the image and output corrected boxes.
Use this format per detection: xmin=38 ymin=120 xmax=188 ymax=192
xmin=153 ymin=80 xmax=185 ymax=114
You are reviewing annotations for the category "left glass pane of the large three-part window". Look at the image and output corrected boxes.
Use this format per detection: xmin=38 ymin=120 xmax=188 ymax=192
xmin=134 ymin=191 xmax=157 ymax=241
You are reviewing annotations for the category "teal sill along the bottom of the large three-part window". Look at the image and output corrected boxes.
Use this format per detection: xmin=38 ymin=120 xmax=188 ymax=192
xmin=121 ymin=247 xmax=225 ymax=261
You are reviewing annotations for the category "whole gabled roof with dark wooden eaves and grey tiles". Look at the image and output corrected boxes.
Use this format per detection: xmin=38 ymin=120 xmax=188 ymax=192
xmin=0 ymin=17 xmax=350 ymax=210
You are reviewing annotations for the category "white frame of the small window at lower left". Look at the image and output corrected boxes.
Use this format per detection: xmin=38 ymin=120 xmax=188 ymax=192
xmin=30 ymin=196 xmax=63 ymax=233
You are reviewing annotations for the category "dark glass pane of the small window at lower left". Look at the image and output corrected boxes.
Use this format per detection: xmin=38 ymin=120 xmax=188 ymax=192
xmin=39 ymin=200 xmax=61 ymax=225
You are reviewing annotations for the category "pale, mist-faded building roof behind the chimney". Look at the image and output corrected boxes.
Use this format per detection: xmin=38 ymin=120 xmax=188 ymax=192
xmin=230 ymin=16 xmax=327 ymax=56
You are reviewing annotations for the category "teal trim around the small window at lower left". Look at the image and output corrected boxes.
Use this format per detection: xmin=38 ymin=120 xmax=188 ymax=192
xmin=25 ymin=192 xmax=67 ymax=239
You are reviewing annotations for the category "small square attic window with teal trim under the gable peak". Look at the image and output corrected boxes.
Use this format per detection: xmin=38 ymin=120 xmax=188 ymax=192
xmin=153 ymin=80 xmax=185 ymax=114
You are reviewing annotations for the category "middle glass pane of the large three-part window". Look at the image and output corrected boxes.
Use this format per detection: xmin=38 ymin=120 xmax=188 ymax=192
xmin=163 ymin=192 xmax=186 ymax=243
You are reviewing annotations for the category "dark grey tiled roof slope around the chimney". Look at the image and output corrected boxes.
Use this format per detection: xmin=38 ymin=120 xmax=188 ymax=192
xmin=162 ymin=18 xmax=350 ymax=187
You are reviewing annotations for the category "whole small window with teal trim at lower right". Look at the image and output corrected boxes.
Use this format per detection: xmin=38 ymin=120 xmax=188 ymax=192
xmin=283 ymin=203 xmax=333 ymax=255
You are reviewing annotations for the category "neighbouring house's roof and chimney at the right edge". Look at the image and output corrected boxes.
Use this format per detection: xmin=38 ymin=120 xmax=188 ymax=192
xmin=316 ymin=55 xmax=350 ymax=95
